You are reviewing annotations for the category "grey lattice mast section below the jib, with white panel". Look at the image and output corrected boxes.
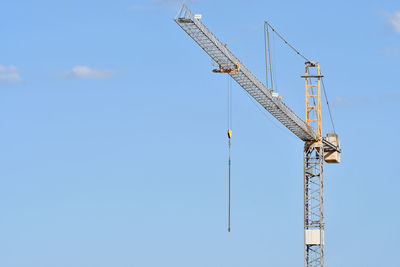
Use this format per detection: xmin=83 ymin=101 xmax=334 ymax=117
xmin=304 ymin=143 xmax=325 ymax=267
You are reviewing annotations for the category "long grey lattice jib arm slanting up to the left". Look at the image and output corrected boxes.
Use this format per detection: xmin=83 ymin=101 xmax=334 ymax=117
xmin=174 ymin=5 xmax=318 ymax=141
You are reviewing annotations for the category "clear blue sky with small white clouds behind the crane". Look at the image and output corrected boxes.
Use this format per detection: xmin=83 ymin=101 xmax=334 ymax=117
xmin=0 ymin=0 xmax=400 ymax=267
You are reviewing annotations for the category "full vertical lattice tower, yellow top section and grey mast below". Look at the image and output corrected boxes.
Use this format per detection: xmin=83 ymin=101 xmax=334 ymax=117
xmin=302 ymin=62 xmax=324 ymax=267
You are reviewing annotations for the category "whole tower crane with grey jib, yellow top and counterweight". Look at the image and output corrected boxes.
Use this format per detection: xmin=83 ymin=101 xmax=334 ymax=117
xmin=174 ymin=5 xmax=341 ymax=267
